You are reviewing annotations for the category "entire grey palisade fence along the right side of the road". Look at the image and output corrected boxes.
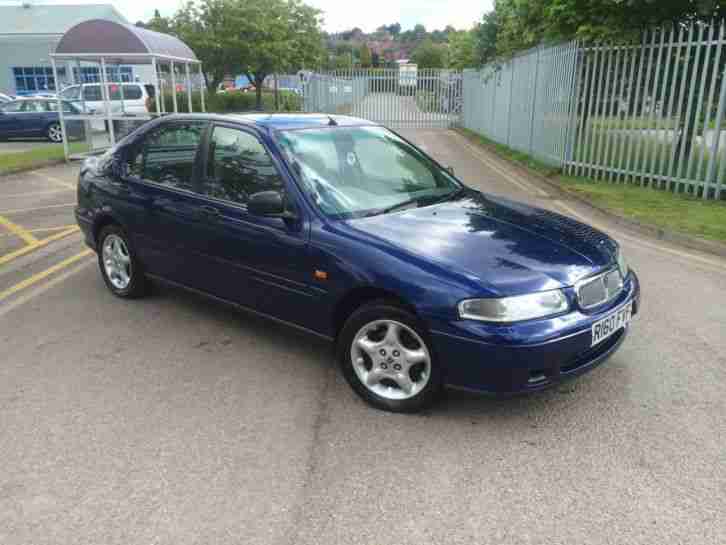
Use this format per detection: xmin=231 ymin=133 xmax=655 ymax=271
xmin=462 ymin=21 xmax=726 ymax=199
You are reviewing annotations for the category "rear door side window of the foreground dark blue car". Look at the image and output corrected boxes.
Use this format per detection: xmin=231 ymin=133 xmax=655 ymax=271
xmin=126 ymin=123 xmax=205 ymax=191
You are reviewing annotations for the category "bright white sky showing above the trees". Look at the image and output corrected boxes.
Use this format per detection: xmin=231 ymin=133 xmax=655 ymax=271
xmin=8 ymin=0 xmax=493 ymax=32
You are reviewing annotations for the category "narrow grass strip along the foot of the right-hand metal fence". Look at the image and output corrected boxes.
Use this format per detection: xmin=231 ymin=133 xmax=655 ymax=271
xmin=460 ymin=129 xmax=726 ymax=242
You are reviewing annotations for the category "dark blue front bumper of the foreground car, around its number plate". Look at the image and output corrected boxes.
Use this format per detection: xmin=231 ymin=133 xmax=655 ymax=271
xmin=432 ymin=273 xmax=640 ymax=394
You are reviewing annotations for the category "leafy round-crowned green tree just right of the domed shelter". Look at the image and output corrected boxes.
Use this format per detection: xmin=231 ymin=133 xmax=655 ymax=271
xmin=166 ymin=0 xmax=323 ymax=109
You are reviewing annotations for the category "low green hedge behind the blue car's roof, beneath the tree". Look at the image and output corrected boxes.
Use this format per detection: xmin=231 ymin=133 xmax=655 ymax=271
xmin=150 ymin=91 xmax=302 ymax=113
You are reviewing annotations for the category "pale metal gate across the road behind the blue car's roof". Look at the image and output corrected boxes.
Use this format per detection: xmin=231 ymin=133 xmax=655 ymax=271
xmin=303 ymin=65 xmax=463 ymax=129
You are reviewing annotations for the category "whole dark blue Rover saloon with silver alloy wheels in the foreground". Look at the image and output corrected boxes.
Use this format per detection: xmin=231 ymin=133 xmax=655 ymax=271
xmin=76 ymin=114 xmax=640 ymax=412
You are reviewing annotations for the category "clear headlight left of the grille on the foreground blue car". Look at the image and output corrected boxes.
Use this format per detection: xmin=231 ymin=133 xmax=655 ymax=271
xmin=459 ymin=290 xmax=569 ymax=322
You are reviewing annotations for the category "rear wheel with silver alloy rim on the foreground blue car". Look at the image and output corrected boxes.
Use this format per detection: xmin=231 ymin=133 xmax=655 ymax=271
xmin=97 ymin=225 xmax=149 ymax=299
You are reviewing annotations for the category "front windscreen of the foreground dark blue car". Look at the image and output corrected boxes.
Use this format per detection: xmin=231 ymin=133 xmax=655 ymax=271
xmin=278 ymin=126 xmax=462 ymax=219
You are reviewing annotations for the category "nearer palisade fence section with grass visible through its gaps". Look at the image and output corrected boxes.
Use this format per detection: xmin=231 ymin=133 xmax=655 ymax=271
xmin=567 ymin=21 xmax=726 ymax=199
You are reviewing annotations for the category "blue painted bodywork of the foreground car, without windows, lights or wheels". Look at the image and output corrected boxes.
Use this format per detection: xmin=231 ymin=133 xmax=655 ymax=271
xmin=76 ymin=114 xmax=640 ymax=392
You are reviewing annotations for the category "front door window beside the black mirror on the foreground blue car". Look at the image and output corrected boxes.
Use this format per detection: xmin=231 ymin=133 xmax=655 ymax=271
xmin=204 ymin=127 xmax=284 ymax=204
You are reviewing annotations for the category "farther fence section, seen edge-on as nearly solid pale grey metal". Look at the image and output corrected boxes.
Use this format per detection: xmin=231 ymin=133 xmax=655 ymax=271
xmin=462 ymin=42 xmax=578 ymax=166
